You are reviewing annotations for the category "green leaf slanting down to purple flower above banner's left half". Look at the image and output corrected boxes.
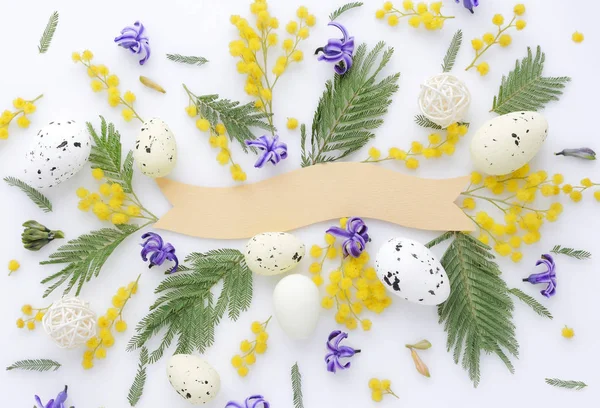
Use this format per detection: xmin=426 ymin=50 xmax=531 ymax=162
xmin=183 ymin=85 xmax=271 ymax=152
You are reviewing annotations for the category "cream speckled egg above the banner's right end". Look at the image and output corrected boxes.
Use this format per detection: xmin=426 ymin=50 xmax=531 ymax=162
xmin=471 ymin=112 xmax=548 ymax=176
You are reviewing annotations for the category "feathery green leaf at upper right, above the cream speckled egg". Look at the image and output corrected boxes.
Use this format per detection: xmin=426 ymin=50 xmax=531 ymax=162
xmin=491 ymin=46 xmax=571 ymax=115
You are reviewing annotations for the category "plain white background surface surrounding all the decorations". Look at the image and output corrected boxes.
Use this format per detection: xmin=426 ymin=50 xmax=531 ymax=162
xmin=0 ymin=0 xmax=600 ymax=408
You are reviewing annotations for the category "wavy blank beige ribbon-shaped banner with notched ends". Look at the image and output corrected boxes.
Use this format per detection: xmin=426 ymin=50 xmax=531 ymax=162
xmin=155 ymin=163 xmax=474 ymax=239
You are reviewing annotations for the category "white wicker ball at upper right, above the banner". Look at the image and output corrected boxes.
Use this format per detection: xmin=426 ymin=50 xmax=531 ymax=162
xmin=419 ymin=74 xmax=471 ymax=128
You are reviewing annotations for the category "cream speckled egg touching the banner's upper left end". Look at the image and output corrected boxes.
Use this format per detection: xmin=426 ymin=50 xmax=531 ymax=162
xmin=133 ymin=118 xmax=177 ymax=178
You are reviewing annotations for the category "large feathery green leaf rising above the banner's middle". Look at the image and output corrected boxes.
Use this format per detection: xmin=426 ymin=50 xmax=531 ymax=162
xmin=302 ymin=42 xmax=400 ymax=167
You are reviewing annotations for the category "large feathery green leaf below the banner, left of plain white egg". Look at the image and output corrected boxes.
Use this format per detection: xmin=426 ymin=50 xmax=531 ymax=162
xmin=127 ymin=249 xmax=252 ymax=363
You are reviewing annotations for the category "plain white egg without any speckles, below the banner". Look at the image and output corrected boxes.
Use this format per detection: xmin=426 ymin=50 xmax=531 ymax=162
xmin=273 ymin=274 xmax=321 ymax=340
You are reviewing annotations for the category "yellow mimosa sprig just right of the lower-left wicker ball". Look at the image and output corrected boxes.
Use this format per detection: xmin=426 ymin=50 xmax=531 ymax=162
xmin=81 ymin=275 xmax=141 ymax=370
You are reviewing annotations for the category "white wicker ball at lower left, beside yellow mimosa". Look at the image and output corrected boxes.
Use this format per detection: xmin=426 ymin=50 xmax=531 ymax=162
xmin=42 ymin=296 xmax=96 ymax=349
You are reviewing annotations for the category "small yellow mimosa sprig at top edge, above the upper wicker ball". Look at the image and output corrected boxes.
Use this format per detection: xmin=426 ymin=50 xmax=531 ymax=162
xmin=375 ymin=0 xmax=454 ymax=30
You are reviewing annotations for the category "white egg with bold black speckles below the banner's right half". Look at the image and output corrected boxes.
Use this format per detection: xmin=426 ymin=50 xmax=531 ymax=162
xmin=375 ymin=238 xmax=450 ymax=306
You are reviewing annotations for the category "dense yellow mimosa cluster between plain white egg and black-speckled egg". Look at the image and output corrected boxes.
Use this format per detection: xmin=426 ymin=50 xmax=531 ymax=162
xmin=309 ymin=218 xmax=392 ymax=331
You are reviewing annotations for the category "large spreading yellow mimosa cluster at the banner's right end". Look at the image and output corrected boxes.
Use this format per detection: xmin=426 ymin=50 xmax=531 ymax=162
xmin=462 ymin=165 xmax=600 ymax=262
